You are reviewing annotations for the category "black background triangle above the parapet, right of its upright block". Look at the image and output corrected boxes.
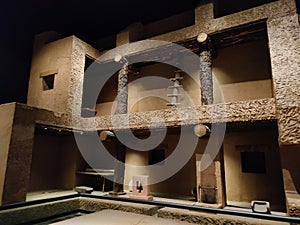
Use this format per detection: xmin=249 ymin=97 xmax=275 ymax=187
xmin=214 ymin=0 xmax=277 ymax=18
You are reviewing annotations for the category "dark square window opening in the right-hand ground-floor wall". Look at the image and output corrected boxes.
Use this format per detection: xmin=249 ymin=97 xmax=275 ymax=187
xmin=241 ymin=152 xmax=266 ymax=173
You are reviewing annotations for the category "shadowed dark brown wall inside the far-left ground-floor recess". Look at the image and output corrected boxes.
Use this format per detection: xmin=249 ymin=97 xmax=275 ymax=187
xmin=28 ymin=135 xmax=87 ymax=191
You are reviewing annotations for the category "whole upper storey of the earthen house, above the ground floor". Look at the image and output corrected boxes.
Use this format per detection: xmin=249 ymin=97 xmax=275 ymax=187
xmin=24 ymin=0 xmax=299 ymax=144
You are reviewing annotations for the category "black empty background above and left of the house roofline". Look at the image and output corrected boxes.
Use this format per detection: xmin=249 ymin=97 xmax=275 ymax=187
xmin=0 ymin=0 xmax=296 ymax=104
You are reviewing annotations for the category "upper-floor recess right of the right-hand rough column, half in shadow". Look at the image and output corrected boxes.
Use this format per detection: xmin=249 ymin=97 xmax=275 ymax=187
xmin=213 ymin=39 xmax=273 ymax=103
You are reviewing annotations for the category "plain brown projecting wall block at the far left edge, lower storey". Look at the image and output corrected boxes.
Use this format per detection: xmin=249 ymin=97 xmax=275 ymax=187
xmin=0 ymin=103 xmax=35 ymax=205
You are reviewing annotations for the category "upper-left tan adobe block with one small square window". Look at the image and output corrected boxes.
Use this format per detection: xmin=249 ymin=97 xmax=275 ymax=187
xmin=28 ymin=33 xmax=99 ymax=117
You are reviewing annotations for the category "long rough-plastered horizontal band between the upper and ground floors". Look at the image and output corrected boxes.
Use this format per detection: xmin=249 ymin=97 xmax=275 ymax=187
xmin=90 ymin=98 xmax=276 ymax=130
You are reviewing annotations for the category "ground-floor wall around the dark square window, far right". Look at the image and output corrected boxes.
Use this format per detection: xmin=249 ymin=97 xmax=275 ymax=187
xmin=223 ymin=129 xmax=284 ymax=210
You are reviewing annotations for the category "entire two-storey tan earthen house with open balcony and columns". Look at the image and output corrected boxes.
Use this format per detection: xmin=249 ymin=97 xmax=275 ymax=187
xmin=0 ymin=0 xmax=300 ymax=220
